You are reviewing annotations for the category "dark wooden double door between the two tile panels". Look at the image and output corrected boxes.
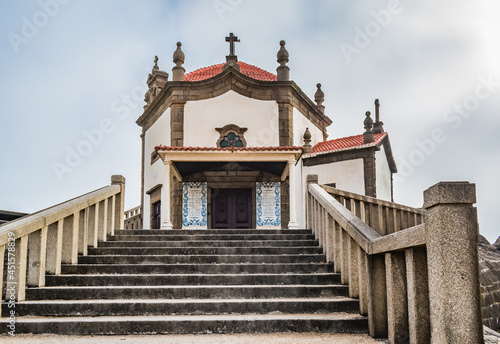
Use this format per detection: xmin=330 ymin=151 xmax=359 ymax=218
xmin=212 ymin=189 xmax=252 ymax=229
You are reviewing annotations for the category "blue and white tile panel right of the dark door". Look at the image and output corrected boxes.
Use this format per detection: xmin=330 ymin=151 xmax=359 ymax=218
xmin=256 ymin=182 xmax=281 ymax=229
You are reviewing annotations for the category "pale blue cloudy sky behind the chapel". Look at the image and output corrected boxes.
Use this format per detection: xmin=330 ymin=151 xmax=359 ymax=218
xmin=0 ymin=0 xmax=500 ymax=242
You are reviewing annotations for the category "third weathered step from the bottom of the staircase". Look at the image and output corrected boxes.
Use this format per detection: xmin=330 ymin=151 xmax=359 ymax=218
xmin=26 ymin=285 xmax=349 ymax=300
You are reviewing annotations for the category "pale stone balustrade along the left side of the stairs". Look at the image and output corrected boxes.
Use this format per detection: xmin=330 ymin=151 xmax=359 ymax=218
xmin=0 ymin=176 xmax=125 ymax=315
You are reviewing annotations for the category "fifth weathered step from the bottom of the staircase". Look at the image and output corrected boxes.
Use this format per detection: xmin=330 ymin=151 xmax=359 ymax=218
xmin=61 ymin=263 xmax=334 ymax=274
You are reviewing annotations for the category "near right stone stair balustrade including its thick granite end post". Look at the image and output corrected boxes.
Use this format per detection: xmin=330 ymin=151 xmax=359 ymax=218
xmin=306 ymin=175 xmax=483 ymax=344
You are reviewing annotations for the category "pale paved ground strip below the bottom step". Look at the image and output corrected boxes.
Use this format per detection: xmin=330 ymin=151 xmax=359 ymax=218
xmin=0 ymin=333 xmax=387 ymax=344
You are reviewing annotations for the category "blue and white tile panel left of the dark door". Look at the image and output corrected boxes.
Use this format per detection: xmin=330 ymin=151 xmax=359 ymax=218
xmin=182 ymin=182 xmax=207 ymax=229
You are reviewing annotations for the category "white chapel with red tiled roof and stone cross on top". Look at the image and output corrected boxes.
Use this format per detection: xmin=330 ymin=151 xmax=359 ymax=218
xmin=137 ymin=33 xmax=397 ymax=229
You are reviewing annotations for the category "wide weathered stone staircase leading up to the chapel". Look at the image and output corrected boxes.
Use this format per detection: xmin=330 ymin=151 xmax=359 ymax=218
xmin=2 ymin=229 xmax=368 ymax=335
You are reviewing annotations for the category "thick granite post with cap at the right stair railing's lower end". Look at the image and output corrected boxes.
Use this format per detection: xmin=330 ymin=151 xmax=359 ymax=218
xmin=424 ymin=182 xmax=483 ymax=344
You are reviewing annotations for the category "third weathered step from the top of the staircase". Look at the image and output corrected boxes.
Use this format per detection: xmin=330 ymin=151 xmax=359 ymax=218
xmin=99 ymin=240 xmax=319 ymax=247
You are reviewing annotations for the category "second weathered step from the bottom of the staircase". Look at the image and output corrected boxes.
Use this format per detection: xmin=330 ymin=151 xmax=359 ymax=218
xmin=2 ymin=297 xmax=359 ymax=316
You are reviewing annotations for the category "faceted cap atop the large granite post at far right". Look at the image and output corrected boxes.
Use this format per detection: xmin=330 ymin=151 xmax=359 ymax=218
xmin=424 ymin=182 xmax=476 ymax=209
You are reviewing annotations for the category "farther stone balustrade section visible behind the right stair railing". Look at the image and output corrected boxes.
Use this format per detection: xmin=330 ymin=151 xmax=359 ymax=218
xmin=322 ymin=185 xmax=425 ymax=235
